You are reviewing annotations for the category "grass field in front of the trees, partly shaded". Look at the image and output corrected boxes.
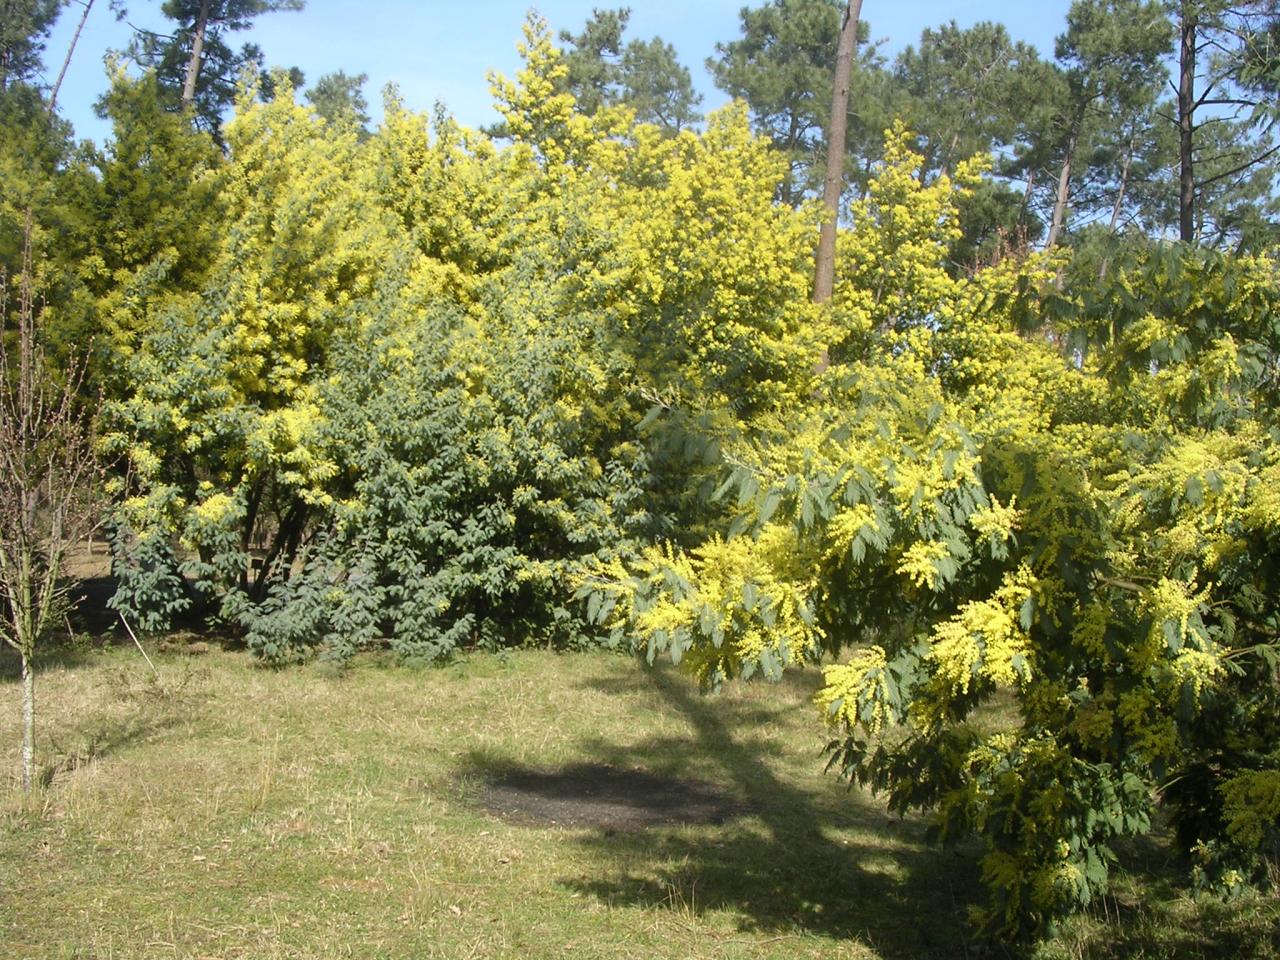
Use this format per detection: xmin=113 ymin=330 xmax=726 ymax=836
xmin=0 ymin=648 xmax=1280 ymax=960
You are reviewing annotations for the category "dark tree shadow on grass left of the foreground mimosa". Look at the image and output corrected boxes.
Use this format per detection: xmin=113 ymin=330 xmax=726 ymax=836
xmin=465 ymin=669 xmax=989 ymax=960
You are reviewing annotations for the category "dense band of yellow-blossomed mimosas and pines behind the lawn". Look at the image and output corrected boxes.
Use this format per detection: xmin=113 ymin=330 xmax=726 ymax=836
xmin=0 ymin=0 xmax=1280 ymax=940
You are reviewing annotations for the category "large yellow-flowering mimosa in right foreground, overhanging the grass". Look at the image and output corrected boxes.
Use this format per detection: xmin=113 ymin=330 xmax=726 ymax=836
xmin=596 ymin=133 xmax=1280 ymax=940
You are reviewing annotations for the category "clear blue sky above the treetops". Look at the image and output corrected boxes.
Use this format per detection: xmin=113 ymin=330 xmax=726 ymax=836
xmin=45 ymin=0 xmax=1069 ymax=141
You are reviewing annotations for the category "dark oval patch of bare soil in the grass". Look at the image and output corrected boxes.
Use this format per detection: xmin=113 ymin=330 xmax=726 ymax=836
xmin=484 ymin=763 xmax=746 ymax=829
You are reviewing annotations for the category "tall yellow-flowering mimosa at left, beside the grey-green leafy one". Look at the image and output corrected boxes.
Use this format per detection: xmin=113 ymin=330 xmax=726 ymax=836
xmin=109 ymin=75 xmax=393 ymax=627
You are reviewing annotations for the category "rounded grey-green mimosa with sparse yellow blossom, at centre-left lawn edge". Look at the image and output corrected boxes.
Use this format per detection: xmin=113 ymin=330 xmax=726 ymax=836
xmin=246 ymin=263 xmax=643 ymax=660
